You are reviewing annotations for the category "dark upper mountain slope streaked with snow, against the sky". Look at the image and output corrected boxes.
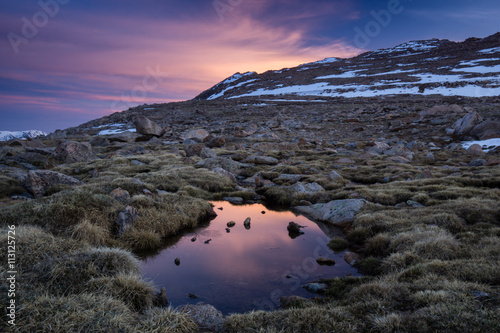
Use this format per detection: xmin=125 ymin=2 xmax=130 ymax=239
xmin=196 ymin=33 xmax=500 ymax=100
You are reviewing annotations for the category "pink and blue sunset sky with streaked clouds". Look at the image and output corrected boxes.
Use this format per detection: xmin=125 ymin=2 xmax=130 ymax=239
xmin=0 ymin=0 xmax=500 ymax=132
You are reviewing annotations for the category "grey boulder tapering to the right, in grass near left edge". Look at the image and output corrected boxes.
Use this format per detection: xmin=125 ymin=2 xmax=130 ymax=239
xmin=25 ymin=170 xmax=82 ymax=198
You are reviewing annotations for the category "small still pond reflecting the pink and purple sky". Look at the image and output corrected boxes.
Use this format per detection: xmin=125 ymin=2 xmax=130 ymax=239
xmin=142 ymin=202 xmax=359 ymax=314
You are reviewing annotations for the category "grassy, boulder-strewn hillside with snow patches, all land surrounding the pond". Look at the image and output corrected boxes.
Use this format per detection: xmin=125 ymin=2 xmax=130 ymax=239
xmin=0 ymin=34 xmax=500 ymax=333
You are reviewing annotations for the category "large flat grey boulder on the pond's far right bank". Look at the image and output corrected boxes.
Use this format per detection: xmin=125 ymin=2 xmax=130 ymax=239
xmin=295 ymin=199 xmax=366 ymax=227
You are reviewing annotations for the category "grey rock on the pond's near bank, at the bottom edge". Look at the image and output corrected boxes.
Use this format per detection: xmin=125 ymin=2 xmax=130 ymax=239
xmin=179 ymin=304 xmax=224 ymax=332
